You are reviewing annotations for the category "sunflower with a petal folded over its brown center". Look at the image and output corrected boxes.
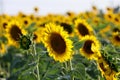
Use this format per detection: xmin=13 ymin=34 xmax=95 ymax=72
xmin=80 ymin=35 xmax=101 ymax=60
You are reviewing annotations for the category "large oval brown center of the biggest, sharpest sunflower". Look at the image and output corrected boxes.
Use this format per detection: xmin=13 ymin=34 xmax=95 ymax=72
xmin=50 ymin=33 xmax=66 ymax=54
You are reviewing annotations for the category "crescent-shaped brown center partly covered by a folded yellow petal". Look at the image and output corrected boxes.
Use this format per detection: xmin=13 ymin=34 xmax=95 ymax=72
xmin=83 ymin=40 xmax=94 ymax=54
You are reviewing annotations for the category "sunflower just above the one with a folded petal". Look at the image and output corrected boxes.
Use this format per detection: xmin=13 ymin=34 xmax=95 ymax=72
xmin=75 ymin=19 xmax=93 ymax=38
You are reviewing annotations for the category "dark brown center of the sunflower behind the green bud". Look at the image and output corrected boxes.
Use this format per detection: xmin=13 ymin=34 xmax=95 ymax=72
xmin=10 ymin=25 xmax=22 ymax=41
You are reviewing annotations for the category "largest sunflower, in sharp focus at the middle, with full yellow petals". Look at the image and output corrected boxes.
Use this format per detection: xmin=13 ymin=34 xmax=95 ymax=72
xmin=42 ymin=23 xmax=73 ymax=62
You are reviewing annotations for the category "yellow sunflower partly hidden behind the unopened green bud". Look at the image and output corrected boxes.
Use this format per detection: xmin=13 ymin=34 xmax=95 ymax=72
xmin=6 ymin=19 xmax=26 ymax=46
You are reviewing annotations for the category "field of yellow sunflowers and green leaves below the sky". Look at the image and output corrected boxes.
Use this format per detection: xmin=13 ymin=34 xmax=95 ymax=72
xmin=0 ymin=6 xmax=120 ymax=80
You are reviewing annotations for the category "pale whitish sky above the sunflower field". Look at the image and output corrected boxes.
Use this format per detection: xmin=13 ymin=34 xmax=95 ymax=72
xmin=0 ymin=0 xmax=120 ymax=15
